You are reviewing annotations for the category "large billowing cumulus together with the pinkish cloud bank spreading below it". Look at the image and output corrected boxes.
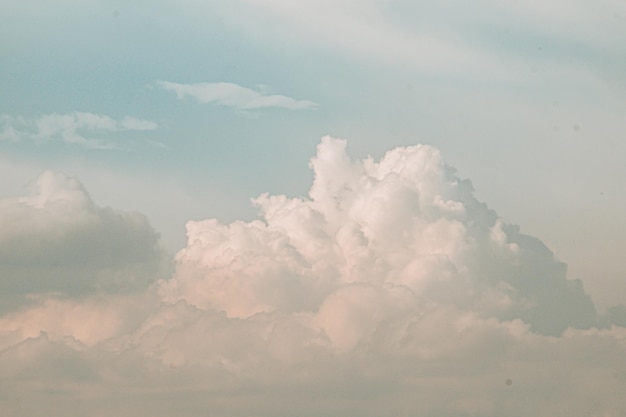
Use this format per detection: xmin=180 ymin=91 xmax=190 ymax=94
xmin=0 ymin=137 xmax=626 ymax=417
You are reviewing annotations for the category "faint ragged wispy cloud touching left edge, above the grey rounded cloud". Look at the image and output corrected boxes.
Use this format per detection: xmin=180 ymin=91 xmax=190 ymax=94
xmin=0 ymin=112 xmax=158 ymax=148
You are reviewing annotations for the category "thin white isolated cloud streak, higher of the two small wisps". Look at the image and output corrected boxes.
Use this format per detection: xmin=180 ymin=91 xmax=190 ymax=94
xmin=156 ymin=81 xmax=317 ymax=110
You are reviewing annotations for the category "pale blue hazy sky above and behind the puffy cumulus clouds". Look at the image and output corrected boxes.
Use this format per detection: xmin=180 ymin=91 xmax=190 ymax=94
xmin=0 ymin=0 xmax=626 ymax=415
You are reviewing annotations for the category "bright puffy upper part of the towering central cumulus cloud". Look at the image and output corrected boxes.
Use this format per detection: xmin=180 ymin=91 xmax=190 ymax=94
xmin=161 ymin=137 xmax=596 ymax=336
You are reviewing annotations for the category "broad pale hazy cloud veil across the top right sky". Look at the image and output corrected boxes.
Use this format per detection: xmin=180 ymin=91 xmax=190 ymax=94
xmin=201 ymin=0 xmax=625 ymax=85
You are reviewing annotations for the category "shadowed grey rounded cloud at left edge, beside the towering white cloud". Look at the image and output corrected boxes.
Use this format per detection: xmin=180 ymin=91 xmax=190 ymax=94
xmin=0 ymin=171 xmax=164 ymax=308
